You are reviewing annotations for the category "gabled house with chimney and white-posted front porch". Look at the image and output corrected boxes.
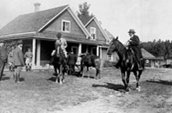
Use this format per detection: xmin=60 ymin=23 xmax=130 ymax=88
xmin=0 ymin=4 xmax=107 ymax=68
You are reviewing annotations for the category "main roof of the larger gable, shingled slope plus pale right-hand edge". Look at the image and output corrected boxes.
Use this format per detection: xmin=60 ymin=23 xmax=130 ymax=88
xmin=0 ymin=5 xmax=89 ymax=37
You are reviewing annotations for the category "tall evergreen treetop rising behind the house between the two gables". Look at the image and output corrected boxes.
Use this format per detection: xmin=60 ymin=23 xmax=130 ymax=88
xmin=77 ymin=2 xmax=93 ymax=25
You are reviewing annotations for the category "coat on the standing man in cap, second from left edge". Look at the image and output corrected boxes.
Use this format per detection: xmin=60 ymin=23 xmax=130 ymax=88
xmin=13 ymin=47 xmax=24 ymax=66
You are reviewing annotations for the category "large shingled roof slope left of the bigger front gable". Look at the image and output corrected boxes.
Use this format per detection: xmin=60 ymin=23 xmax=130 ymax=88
xmin=0 ymin=5 xmax=68 ymax=35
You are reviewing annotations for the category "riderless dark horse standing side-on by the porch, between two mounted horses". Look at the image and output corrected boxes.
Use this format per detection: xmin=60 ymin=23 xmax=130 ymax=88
xmin=80 ymin=54 xmax=102 ymax=79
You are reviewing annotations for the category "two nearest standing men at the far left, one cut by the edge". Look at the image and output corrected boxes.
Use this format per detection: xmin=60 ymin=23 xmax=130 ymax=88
xmin=0 ymin=40 xmax=25 ymax=82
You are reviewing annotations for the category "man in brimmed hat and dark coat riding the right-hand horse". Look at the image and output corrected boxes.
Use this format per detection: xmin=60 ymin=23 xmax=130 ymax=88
xmin=128 ymin=29 xmax=143 ymax=70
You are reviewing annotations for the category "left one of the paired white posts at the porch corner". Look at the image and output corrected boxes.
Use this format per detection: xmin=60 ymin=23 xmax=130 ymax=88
xmin=32 ymin=39 xmax=36 ymax=68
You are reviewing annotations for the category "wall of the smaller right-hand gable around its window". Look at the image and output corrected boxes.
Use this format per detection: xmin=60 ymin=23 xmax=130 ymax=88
xmin=86 ymin=20 xmax=105 ymax=41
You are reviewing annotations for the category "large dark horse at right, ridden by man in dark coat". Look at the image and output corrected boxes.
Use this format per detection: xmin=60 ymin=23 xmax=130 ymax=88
xmin=107 ymin=37 xmax=144 ymax=91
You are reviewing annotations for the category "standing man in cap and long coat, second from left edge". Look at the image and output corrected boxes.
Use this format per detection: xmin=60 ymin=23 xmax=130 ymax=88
xmin=13 ymin=40 xmax=24 ymax=83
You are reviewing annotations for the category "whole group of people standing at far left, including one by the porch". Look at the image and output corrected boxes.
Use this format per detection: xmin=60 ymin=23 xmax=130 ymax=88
xmin=0 ymin=40 xmax=32 ymax=82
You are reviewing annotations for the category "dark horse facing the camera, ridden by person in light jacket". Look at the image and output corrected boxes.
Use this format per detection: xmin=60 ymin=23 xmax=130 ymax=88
xmin=52 ymin=46 xmax=67 ymax=84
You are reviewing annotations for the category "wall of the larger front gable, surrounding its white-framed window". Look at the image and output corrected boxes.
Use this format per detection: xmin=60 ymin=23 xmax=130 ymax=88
xmin=44 ymin=10 xmax=86 ymax=38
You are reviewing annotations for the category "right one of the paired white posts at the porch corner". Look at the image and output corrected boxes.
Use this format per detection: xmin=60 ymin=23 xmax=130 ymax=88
xmin=36 ymin=40 xmax=41 ymax=66
